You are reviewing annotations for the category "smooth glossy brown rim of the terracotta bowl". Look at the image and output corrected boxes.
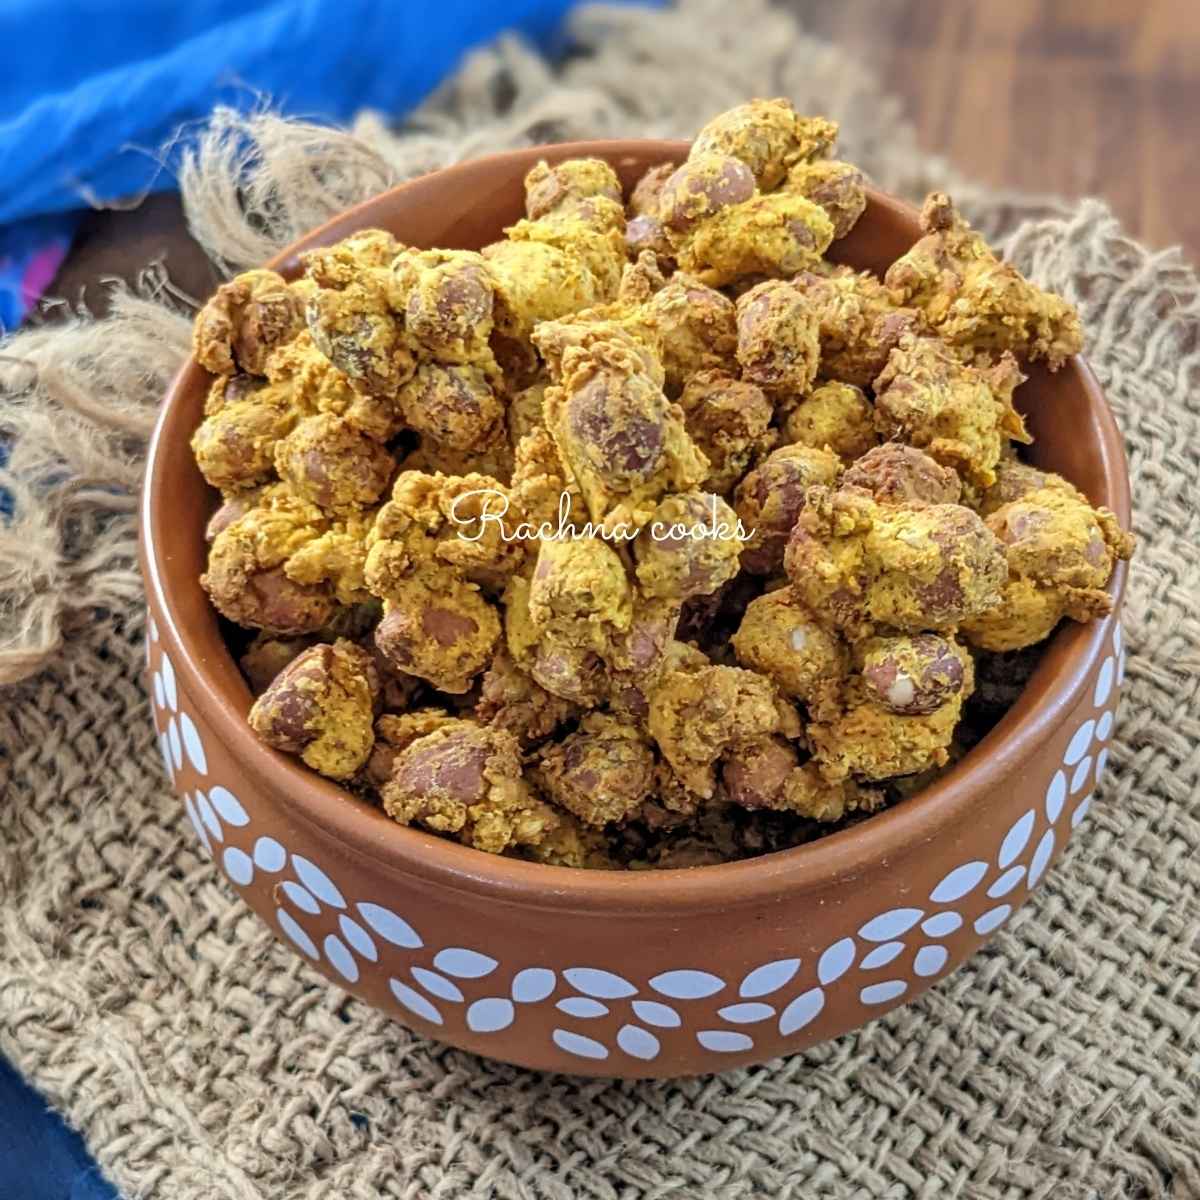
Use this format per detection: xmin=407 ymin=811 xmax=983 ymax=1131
xmin=139 ymin=139 xmax=1130 ymax=918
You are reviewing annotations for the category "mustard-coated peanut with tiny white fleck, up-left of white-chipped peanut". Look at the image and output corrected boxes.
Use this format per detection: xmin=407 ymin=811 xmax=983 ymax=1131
xmin=732 ymin=588 xmax=850 ymax=713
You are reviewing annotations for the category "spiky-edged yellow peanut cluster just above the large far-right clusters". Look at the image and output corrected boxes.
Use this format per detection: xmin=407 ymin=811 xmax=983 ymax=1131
xmin=875 ymin=335 xmax=1032 ymax=487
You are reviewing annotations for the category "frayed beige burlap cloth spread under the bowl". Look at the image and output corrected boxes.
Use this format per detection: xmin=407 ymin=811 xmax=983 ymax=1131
xmin=0 ymin=0 xmax=1200 ymax=1200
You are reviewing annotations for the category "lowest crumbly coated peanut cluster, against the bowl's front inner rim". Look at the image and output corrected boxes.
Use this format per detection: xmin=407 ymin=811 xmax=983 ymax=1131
xmin=382 ymin=720 xmax=559 ymax=854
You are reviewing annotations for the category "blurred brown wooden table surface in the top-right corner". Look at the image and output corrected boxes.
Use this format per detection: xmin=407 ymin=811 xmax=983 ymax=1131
xmin=781 ymin=0 xmax=1200 ymax=262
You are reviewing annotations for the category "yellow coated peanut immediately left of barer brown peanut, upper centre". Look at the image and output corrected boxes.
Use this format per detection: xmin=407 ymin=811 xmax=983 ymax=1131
xmin=641 ymin=272 xmax=738 ymax=396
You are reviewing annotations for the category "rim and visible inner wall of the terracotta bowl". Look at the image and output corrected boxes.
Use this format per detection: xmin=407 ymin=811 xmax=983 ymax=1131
xmin=143 ymin=142 xmax=1129 ymax=911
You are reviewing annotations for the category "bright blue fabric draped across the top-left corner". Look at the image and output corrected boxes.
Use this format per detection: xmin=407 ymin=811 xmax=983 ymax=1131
xmin=0 ymin=0 xmax=590 ymax=224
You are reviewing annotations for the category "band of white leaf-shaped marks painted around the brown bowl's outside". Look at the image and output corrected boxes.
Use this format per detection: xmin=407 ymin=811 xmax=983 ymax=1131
xmin=146 ymin=622 xmax=1126 ymax=1062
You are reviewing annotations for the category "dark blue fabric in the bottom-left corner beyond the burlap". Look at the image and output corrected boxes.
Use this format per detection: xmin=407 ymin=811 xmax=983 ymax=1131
xmin=0 ymin=1058 xmax=118 ymax=1200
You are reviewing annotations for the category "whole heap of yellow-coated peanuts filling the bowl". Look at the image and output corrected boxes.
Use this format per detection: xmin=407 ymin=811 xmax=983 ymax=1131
xmin=192 ymin=100 xmax=1132 ymax=868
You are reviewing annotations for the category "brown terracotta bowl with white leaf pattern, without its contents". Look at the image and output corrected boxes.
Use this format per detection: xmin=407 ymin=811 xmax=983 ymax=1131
xmin=142 ymin=142 xmax=1129 ymax=1076
